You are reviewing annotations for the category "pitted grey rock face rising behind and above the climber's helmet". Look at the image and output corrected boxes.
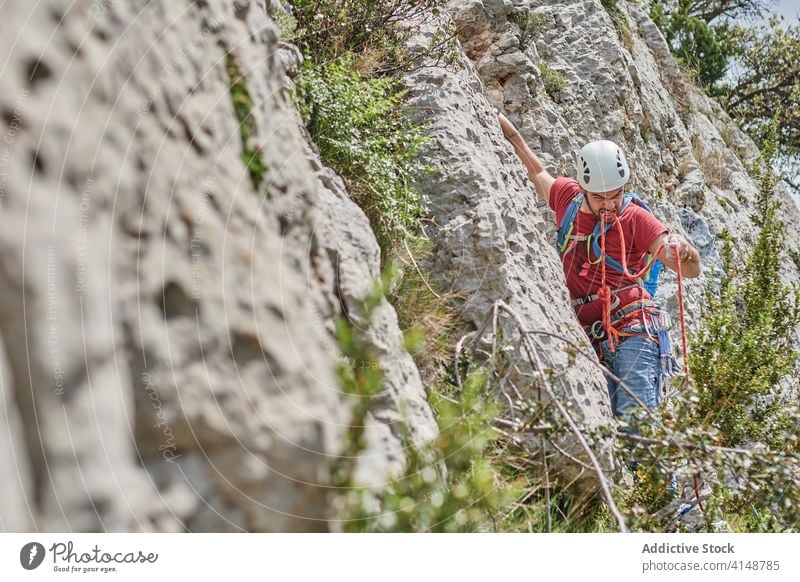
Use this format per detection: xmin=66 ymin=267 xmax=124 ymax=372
xmin=450 ymin=0 xmax=799 ymax=327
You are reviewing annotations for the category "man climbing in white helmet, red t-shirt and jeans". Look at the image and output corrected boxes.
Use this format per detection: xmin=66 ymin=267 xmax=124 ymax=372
xmin=499 ymin=114 xmax=700 ymax=416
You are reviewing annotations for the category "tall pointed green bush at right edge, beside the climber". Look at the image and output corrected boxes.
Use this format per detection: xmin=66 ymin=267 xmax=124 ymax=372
xmin=689 ymin=117 xmax=800 ymax=446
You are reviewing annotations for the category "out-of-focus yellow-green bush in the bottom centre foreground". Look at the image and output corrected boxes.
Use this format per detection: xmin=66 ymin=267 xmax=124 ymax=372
xmin=331 ymin=265 xmax=514 ymax=532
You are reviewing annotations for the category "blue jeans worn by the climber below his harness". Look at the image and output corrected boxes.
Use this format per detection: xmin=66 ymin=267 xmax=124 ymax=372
xmin=601 ymin=329 xmax=661 ymax=416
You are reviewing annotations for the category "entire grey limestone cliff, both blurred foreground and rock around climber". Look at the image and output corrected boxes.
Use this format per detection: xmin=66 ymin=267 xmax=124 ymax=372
xmin=0 ymin=0 xmax=798 ymax=531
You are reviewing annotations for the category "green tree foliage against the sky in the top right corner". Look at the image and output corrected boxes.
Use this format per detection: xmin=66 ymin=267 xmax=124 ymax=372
xmin=650 ymin=0 xmax=800 ymax=191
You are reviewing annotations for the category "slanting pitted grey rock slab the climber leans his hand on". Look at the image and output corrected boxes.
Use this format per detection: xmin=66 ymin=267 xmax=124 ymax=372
xmin=409 ymin=13 xmax=611 ymax=484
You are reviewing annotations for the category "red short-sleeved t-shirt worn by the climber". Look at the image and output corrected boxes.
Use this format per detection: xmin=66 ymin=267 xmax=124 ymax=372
xmin=550 ymin=178 xmax=668 ymax=326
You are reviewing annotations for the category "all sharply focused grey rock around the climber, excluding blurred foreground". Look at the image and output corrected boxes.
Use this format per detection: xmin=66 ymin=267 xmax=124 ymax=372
xmin=409 ymin=0 xmax=797 ymax=488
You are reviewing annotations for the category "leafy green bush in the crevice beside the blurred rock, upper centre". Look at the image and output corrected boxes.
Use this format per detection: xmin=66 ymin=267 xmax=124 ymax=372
xmin=297 ymin=57 xmax=428 ymax=255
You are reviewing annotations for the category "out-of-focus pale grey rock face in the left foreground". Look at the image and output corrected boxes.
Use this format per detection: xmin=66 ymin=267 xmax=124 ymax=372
xmin=0 ymin=1 xmax=436 ymax=531
